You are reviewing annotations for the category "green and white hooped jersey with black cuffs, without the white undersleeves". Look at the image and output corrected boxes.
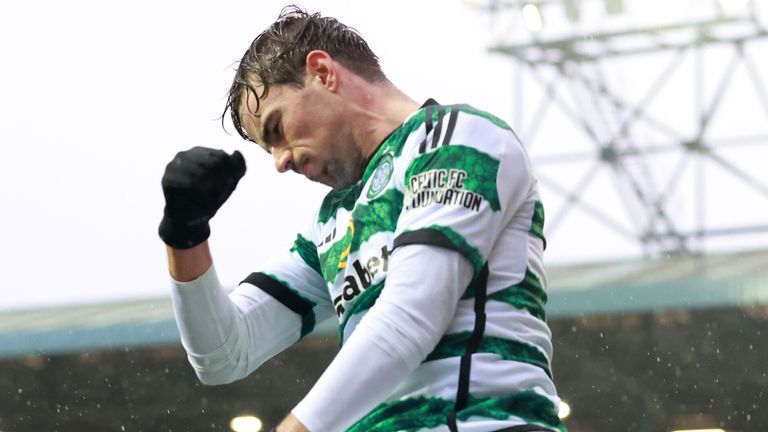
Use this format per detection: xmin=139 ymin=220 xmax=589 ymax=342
xmin=246 ymin=103 xmax=565 ymax=431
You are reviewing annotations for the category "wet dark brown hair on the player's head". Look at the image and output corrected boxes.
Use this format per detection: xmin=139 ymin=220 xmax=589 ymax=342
xmin=221 ymin=5 xmax=387 ymax=141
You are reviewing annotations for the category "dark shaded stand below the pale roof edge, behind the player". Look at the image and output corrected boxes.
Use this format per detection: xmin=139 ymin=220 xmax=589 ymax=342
xmin=0 ymin=306 xmax=768 ymax=432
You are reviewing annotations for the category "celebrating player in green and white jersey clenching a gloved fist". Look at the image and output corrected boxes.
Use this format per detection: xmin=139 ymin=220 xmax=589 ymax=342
xmin=159 ymin=7 xmax=565 ymax=432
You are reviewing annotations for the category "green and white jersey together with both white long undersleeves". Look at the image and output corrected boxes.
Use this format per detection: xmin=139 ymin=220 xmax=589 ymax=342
xmin=174 ymin=101 xmax=565 ymax=431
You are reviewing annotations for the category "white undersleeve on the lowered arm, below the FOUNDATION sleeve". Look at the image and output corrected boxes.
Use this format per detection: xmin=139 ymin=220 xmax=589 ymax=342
xmin=292 ymin=245 xmax=473 ymax=432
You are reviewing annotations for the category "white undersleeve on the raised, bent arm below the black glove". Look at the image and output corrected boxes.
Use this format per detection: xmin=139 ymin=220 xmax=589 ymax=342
xmin=171 ymin=266 xmax=302 ymax=384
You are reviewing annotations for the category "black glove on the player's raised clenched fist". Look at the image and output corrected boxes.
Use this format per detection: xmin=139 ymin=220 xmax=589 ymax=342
xmin=158 ymin=147 xmax=245 ymax=249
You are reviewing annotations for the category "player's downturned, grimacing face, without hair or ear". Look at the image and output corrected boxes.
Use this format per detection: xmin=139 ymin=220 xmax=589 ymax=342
xmin=239 ymin=77 xmax=366 ymax=189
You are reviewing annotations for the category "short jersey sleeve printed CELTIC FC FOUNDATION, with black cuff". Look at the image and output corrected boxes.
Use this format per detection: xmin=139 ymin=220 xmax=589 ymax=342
xmin=394 ymin=106 xmax=533 ymax=273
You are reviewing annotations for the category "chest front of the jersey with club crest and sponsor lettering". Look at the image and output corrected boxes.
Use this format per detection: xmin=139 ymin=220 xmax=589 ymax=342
xmin=316 ymin=132 xmax=408 ymax=342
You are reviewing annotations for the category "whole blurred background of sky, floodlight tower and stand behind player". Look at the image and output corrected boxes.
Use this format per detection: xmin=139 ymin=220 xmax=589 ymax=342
xmin=0 ymin=0 xmax=768 ymax=432
